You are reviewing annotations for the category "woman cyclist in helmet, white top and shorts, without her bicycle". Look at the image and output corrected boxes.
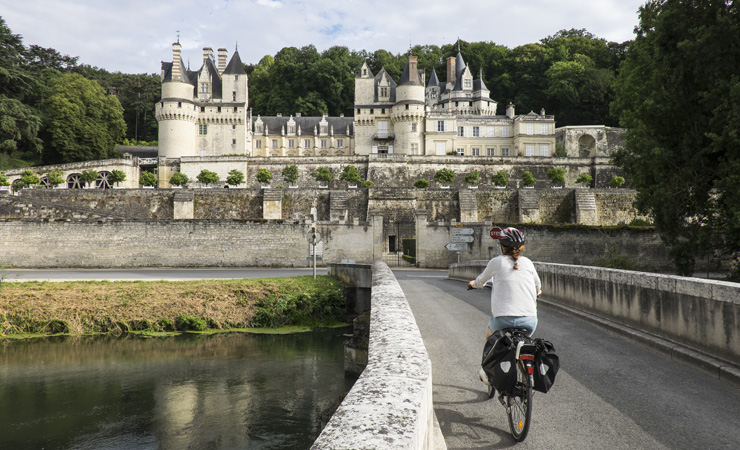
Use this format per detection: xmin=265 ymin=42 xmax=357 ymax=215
xmin=468 ymin=227 xmax=542 ymax=384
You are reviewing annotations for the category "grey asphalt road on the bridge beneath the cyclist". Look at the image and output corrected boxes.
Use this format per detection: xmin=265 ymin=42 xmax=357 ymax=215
xmin=394 ymin=270 xmax=740 ymax=450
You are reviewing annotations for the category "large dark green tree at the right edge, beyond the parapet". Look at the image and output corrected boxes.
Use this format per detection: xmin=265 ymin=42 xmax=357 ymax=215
xmin=612 ymin=0 xmax=740 ymax=275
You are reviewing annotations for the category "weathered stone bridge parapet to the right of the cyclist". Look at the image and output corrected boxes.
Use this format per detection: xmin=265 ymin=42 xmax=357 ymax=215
xmin=449 ymin=261 xmax=740 ymax=379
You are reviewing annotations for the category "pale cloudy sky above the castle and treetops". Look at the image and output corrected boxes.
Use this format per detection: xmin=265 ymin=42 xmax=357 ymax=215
xmin=0 ymin=0 xmax=645 ymax=73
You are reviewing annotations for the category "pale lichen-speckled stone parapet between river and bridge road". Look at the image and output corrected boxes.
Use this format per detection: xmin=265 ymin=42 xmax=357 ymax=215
xmin=311 ymin=262 xmax=446 ymax=450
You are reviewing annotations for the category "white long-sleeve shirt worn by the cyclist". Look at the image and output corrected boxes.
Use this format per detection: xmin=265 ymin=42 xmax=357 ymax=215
xmin=475 ymin=255 xmax=542 ymax=317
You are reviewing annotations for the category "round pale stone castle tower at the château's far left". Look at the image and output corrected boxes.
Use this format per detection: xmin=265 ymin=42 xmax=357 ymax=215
xmin=155 ymin=42 xmax=197 ymax=158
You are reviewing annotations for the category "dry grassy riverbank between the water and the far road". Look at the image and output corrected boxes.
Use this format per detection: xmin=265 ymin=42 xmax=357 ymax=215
xmin=0 ymin=276 xmax=346 ymax=338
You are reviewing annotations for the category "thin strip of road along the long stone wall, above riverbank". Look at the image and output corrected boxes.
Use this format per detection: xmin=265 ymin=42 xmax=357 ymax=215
xmin=0 ymin=267 xmax=326 ymax=281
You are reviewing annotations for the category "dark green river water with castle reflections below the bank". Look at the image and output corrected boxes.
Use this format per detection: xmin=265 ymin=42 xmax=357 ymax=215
xmin=0 ymin=329 xmax=353 ymax=449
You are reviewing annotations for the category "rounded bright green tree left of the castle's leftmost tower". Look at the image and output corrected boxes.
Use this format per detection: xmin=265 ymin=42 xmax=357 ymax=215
xmin=41 ymin=74 xmax=126 ymax=164
